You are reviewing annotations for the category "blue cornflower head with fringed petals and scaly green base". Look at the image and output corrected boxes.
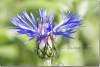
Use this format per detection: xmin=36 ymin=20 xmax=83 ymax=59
xmin=11 ymin=9 xmax=81 ymax=58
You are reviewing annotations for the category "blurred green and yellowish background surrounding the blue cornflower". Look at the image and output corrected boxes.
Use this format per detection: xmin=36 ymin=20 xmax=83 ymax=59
xmin=0 ymin=0 xmax=99 ymax=66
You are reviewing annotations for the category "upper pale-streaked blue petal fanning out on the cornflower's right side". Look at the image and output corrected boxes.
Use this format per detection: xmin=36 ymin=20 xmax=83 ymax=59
xmin=55 ymin=13 xmax=81 ymax=30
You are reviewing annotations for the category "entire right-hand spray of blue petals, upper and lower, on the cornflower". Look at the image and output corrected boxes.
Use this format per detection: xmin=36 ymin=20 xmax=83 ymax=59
xmin=53 ymin=13 xmax=81 ymax=38
